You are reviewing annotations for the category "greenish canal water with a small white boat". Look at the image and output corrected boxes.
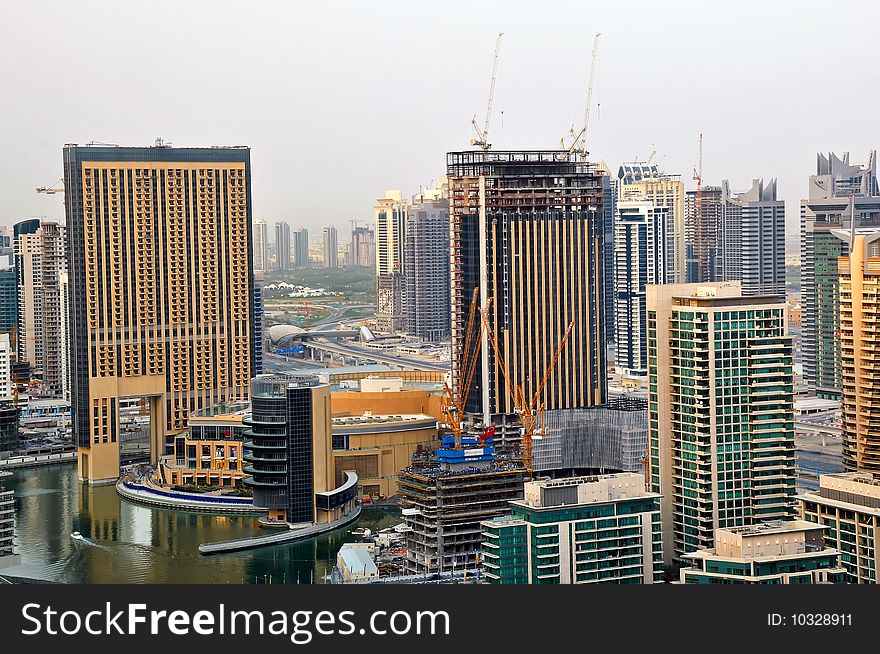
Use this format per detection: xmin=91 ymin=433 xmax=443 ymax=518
xmin=4 ymin=464 xmax=400 ymax=584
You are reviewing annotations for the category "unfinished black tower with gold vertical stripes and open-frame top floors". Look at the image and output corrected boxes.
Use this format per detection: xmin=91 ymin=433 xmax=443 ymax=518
xmin=447 ymin=151 xmax=607 ymax=454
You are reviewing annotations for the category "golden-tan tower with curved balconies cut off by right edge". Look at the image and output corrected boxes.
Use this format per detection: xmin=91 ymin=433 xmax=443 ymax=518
xmin=832 ymin=226 xmax=880 ymax=473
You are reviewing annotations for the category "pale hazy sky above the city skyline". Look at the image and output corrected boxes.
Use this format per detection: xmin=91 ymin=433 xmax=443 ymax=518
xmin=0 ymin=0 xmax=880 ymax=241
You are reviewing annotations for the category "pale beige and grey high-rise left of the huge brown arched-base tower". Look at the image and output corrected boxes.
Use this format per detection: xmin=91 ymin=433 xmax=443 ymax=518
xmin=15 ymin=222 xmax=67 ymax=397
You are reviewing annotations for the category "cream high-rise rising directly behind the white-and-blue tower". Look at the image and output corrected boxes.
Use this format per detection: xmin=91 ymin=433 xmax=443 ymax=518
xmin=617 ymin=161 xmax=686 ymax=284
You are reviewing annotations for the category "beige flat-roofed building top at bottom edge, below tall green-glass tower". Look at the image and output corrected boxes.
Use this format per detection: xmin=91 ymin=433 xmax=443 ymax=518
xmin=680 ymin=520 xmax=846 ymax=585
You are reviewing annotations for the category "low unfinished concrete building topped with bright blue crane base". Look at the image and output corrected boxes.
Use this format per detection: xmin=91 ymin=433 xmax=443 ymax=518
xmin=400 ymin=436 xmax=526 ymax=573
